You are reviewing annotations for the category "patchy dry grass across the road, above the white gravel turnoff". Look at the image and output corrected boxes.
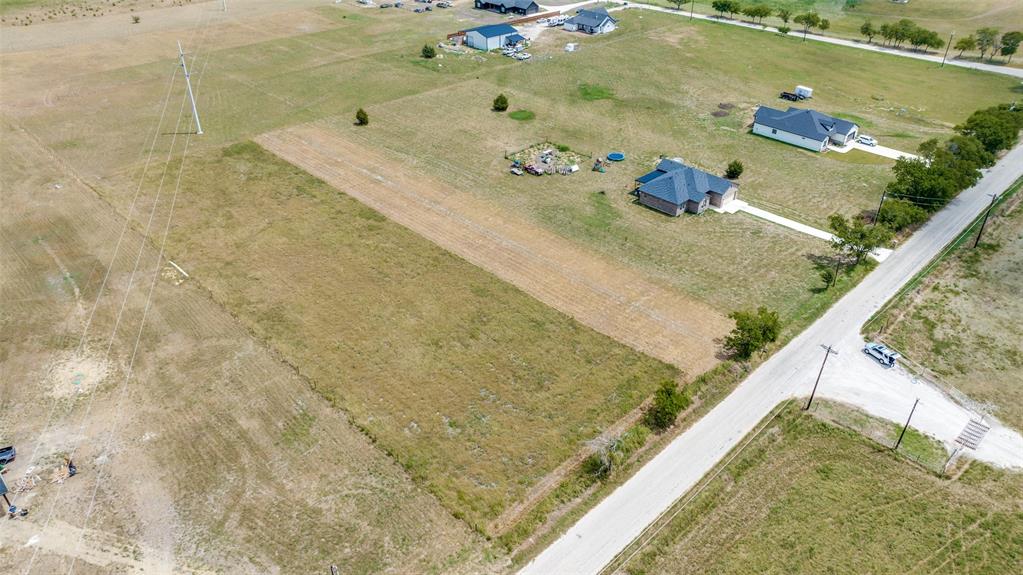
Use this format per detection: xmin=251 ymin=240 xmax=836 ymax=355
xmin=884 ymin=183 xmax=1023 ymax=429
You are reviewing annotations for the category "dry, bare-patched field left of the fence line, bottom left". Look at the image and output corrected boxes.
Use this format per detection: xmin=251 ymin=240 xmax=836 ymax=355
xmin=0 ymin=123 xmax=488 ymax=573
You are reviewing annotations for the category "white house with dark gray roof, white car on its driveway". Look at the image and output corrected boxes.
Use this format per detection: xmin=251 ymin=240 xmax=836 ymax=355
xmin=753 ymin=105 xmax=859 ymax=151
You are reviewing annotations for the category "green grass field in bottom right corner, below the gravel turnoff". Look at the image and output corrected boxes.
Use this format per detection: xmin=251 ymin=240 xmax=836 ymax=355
xmin=625 ymin=405 xmax=1023 ymax=574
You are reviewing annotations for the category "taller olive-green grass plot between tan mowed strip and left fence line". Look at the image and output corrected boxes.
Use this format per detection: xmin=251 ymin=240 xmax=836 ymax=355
xmin=161 ymin=143 xmax=678 ymax=528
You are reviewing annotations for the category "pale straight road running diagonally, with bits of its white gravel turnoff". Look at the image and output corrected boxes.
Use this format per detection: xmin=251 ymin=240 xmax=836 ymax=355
xmin=521 ymin=146 xmax=1023 ymax=575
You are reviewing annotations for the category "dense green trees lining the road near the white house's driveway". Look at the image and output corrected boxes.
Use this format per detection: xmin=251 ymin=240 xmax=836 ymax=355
xmin=877 ymin=104 xmax=1023 ymax=232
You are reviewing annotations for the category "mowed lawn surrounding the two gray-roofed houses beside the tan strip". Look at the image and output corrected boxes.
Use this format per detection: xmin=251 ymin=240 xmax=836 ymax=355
xmin=315 ymin=11 xmax=1015 ymax=321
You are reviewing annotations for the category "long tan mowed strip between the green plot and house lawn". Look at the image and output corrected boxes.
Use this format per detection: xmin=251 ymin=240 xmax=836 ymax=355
xmin=256 ymin=125 xmax=728 ymax=374
